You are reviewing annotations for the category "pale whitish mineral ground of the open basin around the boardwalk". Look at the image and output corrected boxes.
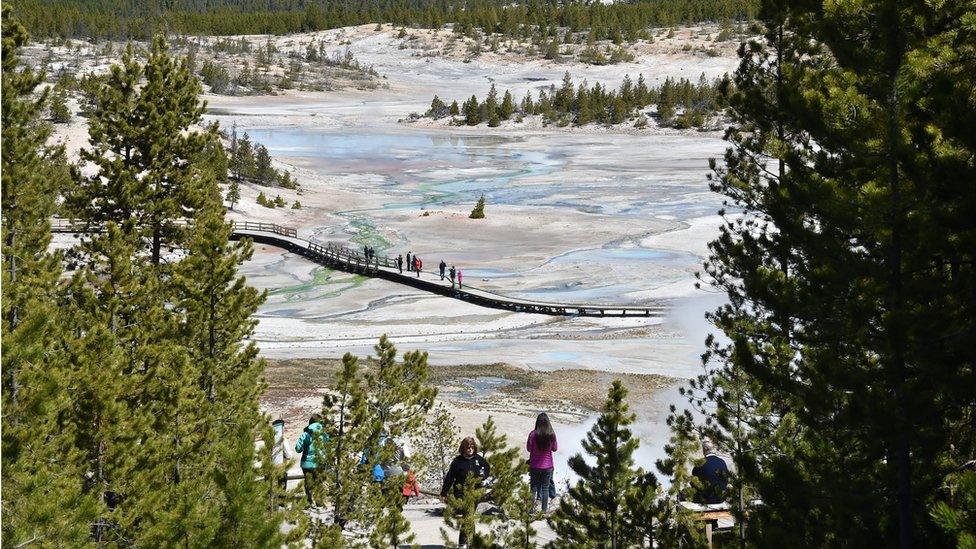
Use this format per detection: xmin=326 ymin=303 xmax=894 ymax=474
xmin=43 ymin=25 xmax=736 ymax=546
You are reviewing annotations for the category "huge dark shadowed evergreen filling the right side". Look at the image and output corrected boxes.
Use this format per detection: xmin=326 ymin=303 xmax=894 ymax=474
xmin=708 ymin=1 xmax=976 ymax=547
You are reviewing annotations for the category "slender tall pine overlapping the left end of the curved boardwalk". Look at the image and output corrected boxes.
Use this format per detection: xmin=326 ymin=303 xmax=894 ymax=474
xmin=175 ymin=196 xmax=282 ymax=546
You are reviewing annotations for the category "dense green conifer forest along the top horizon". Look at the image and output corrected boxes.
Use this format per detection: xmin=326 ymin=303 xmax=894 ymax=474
xmin=11 ymin=0 xmax=758 ymax=42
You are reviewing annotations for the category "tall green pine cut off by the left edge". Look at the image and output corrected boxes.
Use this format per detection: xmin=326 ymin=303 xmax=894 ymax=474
xmin=0 ymin=5 xmax=101 ymax=547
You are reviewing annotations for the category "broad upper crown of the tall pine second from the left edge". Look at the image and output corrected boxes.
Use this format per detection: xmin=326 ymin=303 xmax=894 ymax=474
xmin=67 ymin=37 xmax=209 ymax=266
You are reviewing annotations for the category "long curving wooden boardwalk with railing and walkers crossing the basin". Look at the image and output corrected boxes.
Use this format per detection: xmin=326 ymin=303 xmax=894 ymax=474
xmin=51 ymin=219 xmax=667 ymax=317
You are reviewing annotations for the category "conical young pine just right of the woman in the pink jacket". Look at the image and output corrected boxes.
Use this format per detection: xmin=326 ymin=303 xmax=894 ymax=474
xmin=550 ymin=380 xmax=639 ymax=549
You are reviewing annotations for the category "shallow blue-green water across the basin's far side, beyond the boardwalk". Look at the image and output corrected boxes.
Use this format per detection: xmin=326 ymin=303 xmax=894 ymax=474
xmin=248 ymin=128 xmax=719 ymax=219
